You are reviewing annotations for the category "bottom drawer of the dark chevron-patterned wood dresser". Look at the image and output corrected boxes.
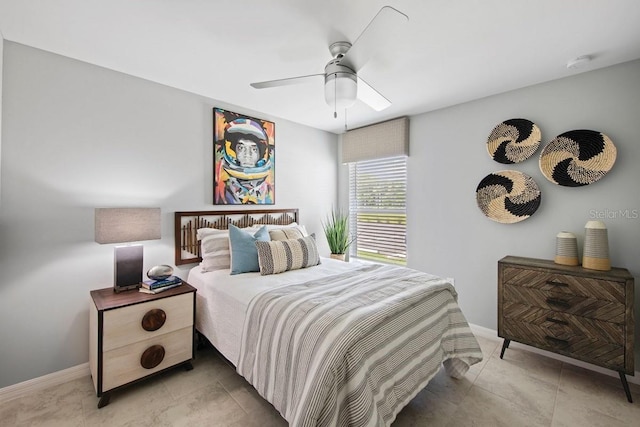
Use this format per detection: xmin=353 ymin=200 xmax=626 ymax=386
xmin=503 ymin=318 xmax=629 ymax=371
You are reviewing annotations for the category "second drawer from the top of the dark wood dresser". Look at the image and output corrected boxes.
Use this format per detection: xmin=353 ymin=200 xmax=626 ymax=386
xmin=501 ymin=284 xmax=625 ymax=324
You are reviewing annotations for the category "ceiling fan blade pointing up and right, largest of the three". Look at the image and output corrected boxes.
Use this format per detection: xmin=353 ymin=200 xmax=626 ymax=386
xmin=340 ymin=6 xmax=409 ymax=71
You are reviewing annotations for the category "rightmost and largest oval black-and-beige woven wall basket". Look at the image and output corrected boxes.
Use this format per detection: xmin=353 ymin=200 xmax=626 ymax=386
xmin=540 ymin=130 xmax=617 ymax=187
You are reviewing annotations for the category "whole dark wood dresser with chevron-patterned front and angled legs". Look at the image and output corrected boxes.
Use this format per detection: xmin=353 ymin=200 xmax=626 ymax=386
xmin=498 ymin=256 xmax=634 ymax=402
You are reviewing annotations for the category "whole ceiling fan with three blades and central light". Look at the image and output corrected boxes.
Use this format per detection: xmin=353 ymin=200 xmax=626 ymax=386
xmin=251 ymin=6 xmax=409 ymax=117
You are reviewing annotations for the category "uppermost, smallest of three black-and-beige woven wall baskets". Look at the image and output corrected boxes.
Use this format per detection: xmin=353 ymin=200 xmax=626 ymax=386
xmin=487 ymin=119 xmax=541 ymax=164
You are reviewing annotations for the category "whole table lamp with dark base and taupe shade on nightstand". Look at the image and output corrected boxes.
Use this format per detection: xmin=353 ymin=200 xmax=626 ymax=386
xmin=95 ymin=208 xmax=160 ymax=292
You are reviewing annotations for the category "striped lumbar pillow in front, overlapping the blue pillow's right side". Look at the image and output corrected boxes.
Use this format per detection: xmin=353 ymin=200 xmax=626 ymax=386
xmin=256 ymin=234 xmax=320 ymax=276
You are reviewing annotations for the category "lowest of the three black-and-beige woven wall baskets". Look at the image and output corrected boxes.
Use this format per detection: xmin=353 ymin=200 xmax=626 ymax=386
xmin=476 ymin=170 xmax=542 ymax=224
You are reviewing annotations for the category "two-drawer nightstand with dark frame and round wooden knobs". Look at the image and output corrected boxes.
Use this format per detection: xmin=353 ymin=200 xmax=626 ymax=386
xmin=89 ymin=282 xmax=196 ymax=408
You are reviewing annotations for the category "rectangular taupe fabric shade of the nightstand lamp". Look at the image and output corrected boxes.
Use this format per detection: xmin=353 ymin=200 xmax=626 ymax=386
xmin=95 ymin=208 xmax=161 ymax=243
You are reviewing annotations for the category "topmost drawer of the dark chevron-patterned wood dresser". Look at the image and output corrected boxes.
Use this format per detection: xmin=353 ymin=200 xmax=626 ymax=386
xmin=502 ymin=266 xmax=625 ymax=304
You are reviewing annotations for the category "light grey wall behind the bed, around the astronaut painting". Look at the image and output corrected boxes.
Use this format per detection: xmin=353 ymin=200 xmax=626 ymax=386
xmin=0 ymin=42 xmax=337 ymax=387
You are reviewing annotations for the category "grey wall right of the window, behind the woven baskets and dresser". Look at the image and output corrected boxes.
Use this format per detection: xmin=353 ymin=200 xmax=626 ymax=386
xmin=408 ymin=61 xmax=640 ymax=369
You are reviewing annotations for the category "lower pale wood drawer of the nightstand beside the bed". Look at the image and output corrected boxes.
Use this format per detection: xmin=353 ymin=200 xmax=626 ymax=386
xmin=102 ymin=326 xmax=193 ymax=391
